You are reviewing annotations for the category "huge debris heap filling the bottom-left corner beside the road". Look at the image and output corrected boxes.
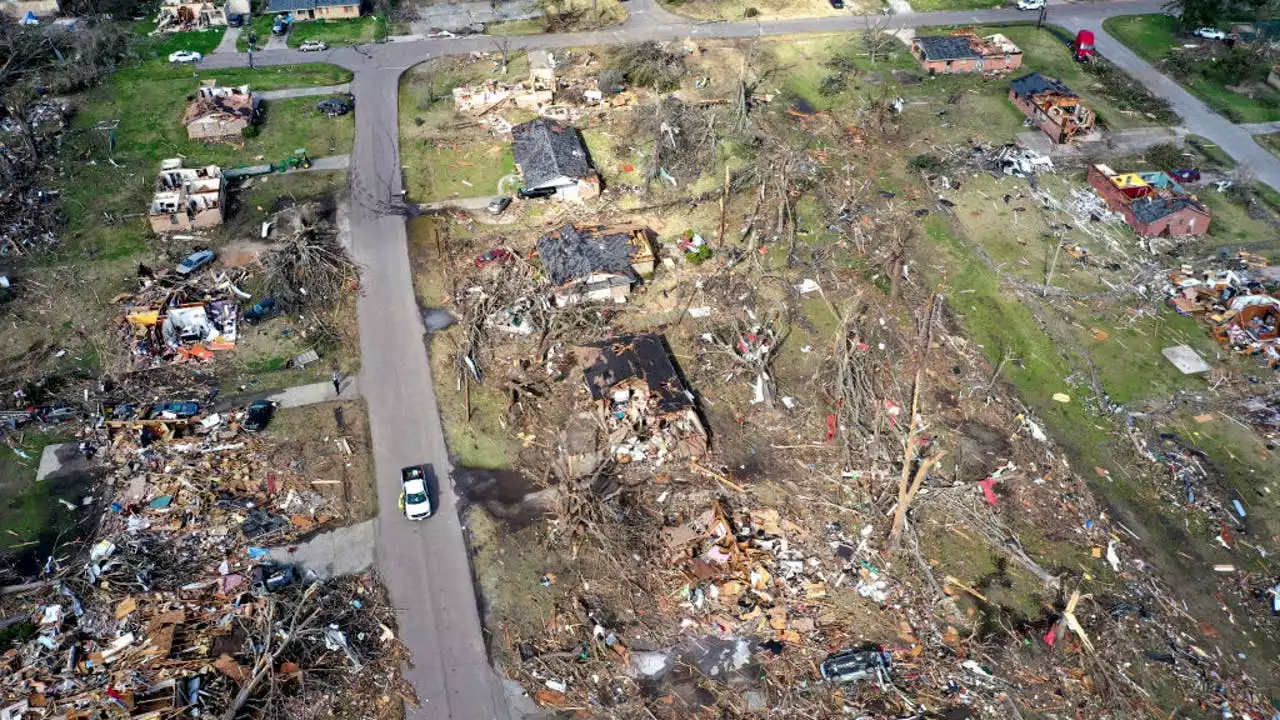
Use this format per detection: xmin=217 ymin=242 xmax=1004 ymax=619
xmin=0 ymin=401 xmax=413 ymax=717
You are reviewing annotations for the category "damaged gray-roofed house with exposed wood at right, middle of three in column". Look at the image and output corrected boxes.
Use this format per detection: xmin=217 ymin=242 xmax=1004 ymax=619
xmin=538 ymin=224 xmax=655 ymax=306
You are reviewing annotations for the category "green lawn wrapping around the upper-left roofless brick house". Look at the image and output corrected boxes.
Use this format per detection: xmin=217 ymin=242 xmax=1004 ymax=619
xmin=60 ymin=61 xmax=355 ymax=260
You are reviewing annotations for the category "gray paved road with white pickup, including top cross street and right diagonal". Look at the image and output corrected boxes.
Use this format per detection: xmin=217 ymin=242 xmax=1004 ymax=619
xmin=202 ymin=0 xmax=1280 ymax=720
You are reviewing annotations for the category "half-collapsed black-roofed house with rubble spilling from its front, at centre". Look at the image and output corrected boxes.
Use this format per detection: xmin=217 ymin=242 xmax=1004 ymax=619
xmin=566 ymin=334 xmax=707 ymax=469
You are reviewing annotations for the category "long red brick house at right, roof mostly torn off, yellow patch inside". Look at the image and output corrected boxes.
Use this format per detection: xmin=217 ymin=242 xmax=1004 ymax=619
xmin=1089 ymin=165 xmax=1212 ymax=237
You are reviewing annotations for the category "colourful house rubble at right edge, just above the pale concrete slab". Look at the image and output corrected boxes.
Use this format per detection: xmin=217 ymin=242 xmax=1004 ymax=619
xmin=1160 ymin=251 xmax=1280 ymax=368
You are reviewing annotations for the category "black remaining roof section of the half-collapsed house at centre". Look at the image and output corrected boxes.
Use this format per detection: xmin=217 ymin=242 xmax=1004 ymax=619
xmin=577 ymin=334 xmax=694 ymax=413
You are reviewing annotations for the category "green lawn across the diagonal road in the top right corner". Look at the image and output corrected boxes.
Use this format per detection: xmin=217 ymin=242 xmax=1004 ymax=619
xmin=1102 ymin=14 xmax=1280 ymax=123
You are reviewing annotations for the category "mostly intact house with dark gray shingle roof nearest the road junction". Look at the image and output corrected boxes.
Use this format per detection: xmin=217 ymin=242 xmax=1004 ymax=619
xmin=511 ymin=118 xmax=600 ymax=200
